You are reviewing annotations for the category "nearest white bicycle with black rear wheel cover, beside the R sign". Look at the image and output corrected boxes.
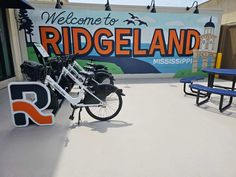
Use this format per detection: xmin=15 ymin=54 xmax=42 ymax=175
xmin=20 ymin=60 xmax=125 ymax=124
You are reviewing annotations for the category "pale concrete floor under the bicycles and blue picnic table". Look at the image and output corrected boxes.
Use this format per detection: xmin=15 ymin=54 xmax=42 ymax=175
xmin=0 ymin=79 xmax=236 ymax=177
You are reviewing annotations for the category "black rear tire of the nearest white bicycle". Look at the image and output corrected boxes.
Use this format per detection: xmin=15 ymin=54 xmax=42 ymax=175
xmin=85 ymin=92 xmax=123 ymax=121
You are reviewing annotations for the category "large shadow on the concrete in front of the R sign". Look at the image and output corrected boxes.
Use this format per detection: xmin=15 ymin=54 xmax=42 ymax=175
xmin=0 ymin=125 xmax=68 ymax=177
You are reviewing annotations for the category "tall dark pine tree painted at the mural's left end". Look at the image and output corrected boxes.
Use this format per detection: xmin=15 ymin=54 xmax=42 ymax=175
xmin=18 ymin=9 xmax=34 ymax=42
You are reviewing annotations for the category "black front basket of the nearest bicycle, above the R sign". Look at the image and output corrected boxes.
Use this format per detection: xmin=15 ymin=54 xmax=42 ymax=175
xmin=20 ymin=61 xmax=46 ymax=81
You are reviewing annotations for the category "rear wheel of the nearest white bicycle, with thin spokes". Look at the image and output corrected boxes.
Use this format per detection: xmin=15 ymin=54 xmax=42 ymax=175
xmin=85 ymin=92 xmax=123 ymax=121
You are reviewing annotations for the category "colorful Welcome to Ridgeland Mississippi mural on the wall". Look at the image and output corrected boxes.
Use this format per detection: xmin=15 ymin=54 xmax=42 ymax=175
xmin=18 ymin=9 xmax=221 ymax=77
